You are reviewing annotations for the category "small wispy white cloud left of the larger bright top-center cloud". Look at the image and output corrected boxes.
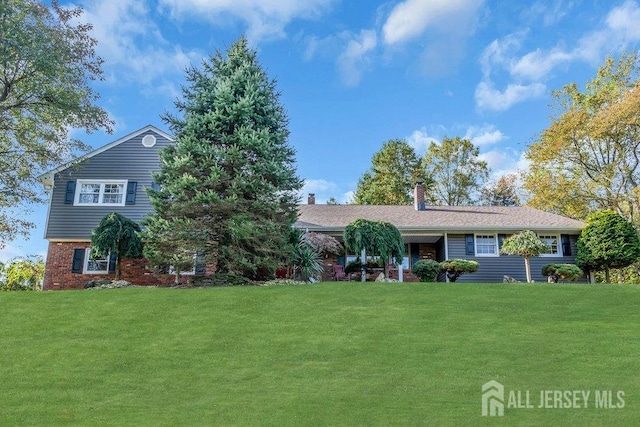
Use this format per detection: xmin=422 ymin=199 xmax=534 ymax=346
xmin=337 ymin=30 xmax=378 ymax=86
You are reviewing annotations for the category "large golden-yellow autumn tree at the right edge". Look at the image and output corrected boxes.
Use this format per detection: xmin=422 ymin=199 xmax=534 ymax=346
xmin=524 ymin=52 xmax=640 ymax=222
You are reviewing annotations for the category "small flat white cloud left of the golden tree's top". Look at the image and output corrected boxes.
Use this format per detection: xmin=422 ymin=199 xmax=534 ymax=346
xmin=475 ymin=81 xmax=546 ymax=111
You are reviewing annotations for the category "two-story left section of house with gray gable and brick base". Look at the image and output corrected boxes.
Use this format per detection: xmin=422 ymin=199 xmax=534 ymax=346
xmin=41 ymin=126 xmax=174 ymax=289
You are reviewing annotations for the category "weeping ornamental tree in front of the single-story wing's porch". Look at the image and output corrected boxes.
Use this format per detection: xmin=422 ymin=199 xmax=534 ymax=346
xmin=344 ymin=219 xmax=404 ymax=281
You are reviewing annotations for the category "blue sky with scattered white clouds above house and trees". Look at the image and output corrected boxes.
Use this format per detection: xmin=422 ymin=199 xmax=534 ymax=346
xmin=0 ymin=0 xmax=640 ymax=261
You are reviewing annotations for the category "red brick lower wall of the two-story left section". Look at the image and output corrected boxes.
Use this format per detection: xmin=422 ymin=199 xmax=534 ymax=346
xmin=43 ymin=242 xmax=195 ymax=290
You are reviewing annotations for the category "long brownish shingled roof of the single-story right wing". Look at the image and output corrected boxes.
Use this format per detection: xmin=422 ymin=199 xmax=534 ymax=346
xmin=295 ymin=204 xmax=585 ymax=234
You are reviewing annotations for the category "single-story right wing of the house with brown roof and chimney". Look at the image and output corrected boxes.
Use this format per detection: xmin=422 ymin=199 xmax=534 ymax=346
xmin=295 ymin=184 xmax=585 ymax=283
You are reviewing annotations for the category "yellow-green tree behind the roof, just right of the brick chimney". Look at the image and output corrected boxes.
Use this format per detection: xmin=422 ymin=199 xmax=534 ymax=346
xmin=423 ymin=137 xmax=489 ymax=206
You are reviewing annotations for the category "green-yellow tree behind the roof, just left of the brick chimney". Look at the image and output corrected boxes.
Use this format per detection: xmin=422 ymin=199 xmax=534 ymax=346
xmin=354 ymin=139 xmax=430 ymax=205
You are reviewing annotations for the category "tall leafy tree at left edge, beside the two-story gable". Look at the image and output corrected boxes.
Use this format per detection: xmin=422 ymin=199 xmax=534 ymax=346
xmin=0 ymin=0 xmax=112 ymax=247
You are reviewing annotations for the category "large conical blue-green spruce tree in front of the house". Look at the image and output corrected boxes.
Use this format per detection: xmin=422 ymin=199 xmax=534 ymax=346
xmin=147 ymin=38 xmax=302 ymax=276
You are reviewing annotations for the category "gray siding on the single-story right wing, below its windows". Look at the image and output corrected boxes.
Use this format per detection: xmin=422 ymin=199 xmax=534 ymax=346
xmin=447 ymin=232 xmax=578 ymax=283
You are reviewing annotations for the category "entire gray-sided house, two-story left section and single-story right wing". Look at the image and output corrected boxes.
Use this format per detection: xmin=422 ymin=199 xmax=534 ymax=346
xmin=41 ymin=126 xmax=584 ymax=289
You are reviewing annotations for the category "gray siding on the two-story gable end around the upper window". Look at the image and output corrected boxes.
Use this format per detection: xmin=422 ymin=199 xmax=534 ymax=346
xmin=45 ymin=130 xmax=173 ymax=240
